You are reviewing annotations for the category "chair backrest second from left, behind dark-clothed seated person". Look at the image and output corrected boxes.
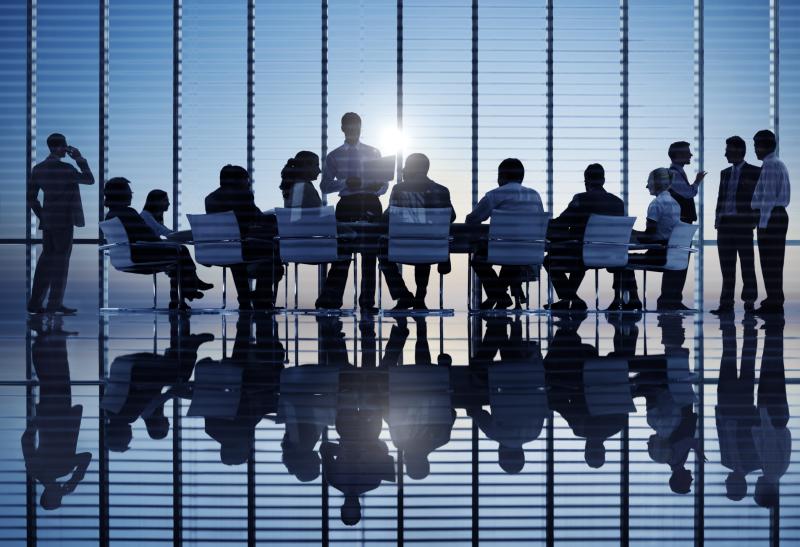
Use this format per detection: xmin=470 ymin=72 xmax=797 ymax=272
xmin=186 ymin=211 xmax=244 ymax=266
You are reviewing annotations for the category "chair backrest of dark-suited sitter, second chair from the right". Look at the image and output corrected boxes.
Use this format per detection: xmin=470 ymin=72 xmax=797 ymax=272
xmin=583 ymin=215 xmax=636 ymax=268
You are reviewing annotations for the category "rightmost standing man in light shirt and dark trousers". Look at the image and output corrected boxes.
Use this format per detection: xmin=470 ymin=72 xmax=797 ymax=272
xmin=751 ymin=129 xmax=791 ymax=314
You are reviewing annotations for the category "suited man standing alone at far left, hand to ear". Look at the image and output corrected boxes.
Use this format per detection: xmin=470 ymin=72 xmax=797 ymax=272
xmin=27 ymin=133 xmax=94 ymax=315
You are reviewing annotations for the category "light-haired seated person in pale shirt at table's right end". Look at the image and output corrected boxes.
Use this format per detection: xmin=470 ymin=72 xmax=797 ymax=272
xmin=607 ymin=167 xmax=681 ymax=311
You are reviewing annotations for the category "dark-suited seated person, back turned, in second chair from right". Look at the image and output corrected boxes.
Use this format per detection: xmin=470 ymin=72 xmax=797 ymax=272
xmin=544 ymin=163 xmax=625 ymax=311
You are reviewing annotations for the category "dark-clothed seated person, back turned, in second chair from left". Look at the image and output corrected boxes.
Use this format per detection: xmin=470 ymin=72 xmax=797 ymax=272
xmin=205 ymin=164 xmax=283 ymax=311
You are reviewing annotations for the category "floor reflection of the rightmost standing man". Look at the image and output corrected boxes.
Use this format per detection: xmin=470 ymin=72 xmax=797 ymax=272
xmin=752 ymin=315 xmax=792 ymax=507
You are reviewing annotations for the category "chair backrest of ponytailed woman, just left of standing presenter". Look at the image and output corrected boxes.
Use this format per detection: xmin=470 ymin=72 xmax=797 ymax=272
xmin=275 ymin=207 xmax=339 ymax=264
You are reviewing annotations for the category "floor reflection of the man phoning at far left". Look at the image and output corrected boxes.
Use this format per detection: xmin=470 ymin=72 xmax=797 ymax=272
xmin=22 ymin=322 xmax=92 ymax=510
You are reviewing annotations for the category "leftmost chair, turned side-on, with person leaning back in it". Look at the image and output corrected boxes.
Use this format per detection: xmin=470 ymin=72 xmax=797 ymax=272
xmin=99 ymin=218 xmax=181 ymax=311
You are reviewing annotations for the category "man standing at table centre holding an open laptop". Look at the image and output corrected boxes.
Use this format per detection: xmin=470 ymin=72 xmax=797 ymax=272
xmin=317 ymin=112 xmax=389 ymax=311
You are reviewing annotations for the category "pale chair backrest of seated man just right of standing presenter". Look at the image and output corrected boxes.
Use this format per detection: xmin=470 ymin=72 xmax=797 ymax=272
xmin=389 ymin=205 xmax=451 ymax=264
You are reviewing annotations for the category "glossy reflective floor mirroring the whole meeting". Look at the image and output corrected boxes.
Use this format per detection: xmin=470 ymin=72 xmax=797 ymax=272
xmin=0 ymin=310 xmax=800 ymax=545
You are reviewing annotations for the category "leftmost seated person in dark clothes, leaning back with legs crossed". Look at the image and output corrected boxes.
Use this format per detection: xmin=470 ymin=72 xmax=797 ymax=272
xmin=103 ymin=177 xmax=214 ymax=310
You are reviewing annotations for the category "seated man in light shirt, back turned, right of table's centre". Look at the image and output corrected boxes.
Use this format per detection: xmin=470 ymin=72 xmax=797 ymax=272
xmin=466 ymin=158 xmax=544 ymax=309
